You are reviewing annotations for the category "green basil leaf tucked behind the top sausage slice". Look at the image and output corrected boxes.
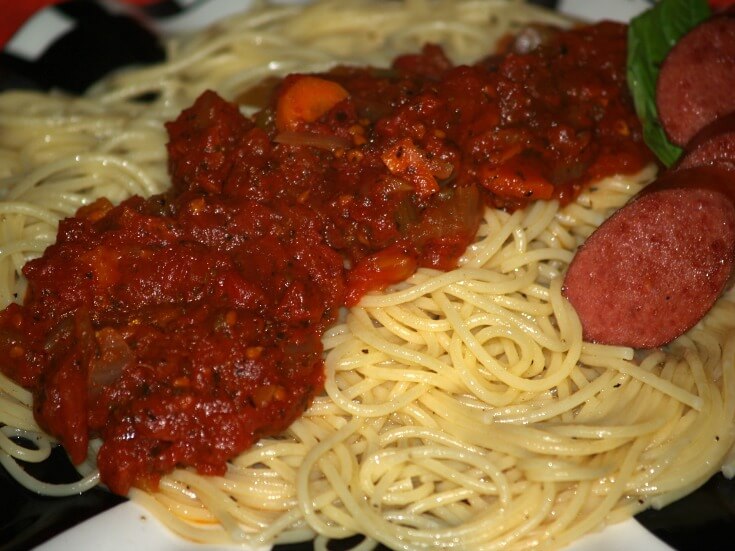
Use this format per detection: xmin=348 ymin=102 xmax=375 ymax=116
xmin=627 ymin=0 xmax=711 ymax=166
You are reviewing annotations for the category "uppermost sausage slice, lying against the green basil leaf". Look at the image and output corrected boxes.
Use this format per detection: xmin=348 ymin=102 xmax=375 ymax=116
xmin=656 ymin=15 xmax=735 ymax=147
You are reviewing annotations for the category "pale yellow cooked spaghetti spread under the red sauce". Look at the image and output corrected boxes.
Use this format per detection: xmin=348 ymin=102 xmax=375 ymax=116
xmin=0 ymin=0 xmax=735 ymax=549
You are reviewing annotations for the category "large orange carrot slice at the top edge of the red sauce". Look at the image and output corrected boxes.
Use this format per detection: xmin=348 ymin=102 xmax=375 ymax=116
xmin=276 ymin=75 xmax=349 ymax=131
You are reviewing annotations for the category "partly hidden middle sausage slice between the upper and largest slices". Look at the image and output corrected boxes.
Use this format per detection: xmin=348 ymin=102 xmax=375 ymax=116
xmin=674 ymin=113 xmax=735 ymax=170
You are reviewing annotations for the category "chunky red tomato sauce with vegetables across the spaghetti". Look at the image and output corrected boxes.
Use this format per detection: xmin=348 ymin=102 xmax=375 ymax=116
xmin=0 ymin=23 xmax=652 ymax=494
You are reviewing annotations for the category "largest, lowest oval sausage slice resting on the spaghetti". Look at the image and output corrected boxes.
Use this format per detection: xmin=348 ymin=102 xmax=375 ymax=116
xmin=563 ymin=166 xmax=735 ymax=348
